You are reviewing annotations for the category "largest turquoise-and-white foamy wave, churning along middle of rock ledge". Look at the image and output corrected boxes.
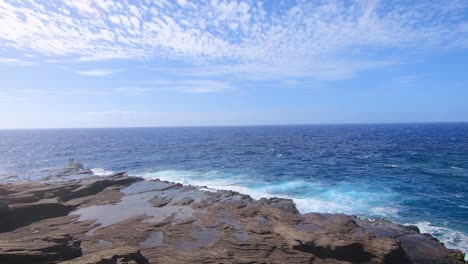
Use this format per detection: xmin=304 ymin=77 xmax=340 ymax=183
xmin=136 ymin=170 xmax=398 ymax=218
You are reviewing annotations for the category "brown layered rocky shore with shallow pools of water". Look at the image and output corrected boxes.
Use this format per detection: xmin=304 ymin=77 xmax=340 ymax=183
xmin=0 ymin=168 xmax=465 ymax=263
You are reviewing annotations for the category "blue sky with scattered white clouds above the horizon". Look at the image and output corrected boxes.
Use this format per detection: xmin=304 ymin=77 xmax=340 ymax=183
xmin=0 ymin=0 xmax=468 ymax=129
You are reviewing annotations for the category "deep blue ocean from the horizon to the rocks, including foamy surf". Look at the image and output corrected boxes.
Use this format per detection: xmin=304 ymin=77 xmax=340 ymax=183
xmin=0 ymin=123 xmax=468 ymax=252
